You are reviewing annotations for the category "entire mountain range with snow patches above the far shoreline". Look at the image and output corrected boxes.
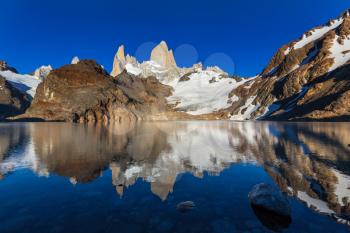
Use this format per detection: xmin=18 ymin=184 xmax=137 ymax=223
xmin=0 ymin=10 xmax=350 ymax=122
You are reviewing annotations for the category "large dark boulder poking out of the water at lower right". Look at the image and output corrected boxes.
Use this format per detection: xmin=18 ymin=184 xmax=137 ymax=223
xmin=248 ymin=183 xmax=291 ymax=216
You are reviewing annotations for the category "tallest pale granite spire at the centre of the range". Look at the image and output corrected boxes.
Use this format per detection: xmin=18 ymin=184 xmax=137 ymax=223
xmin=151 ymin=41 xmax=176 ymax=68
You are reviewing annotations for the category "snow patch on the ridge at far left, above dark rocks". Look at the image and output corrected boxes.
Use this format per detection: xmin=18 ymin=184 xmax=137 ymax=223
xmin=0 ymin=70 xmax=42 ymax=98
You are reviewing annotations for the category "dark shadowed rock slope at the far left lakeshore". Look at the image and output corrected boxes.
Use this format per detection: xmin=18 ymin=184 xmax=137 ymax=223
xmin=0 ymin=76 xmax=30 ymax=120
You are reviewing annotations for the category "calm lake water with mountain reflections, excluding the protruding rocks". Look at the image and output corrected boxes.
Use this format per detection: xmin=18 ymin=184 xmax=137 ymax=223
xmin=0 ymin=121 xmax=350 ymax=233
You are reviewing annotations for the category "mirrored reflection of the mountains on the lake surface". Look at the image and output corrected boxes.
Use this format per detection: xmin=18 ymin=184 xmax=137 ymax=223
xmin=0 ymin=122 xmax=350 ymax=222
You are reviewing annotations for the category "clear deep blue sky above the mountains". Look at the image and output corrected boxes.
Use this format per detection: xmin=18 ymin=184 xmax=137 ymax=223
xmin=0 ymin=0 xmax=350 ymax=76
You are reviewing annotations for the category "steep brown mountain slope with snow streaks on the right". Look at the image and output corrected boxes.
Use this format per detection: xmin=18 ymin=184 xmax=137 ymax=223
xmin=227 ymin=10 xmax=350 ymax=120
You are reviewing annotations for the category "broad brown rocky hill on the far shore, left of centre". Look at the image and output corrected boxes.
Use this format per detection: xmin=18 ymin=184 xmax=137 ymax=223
xmin=21 ymin=60 xmax=170 ymax=122
